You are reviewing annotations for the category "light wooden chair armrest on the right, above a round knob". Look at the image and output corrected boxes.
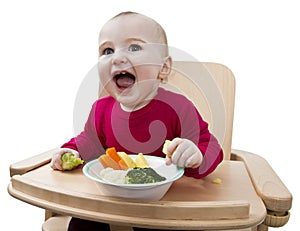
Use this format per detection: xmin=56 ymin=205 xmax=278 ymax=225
xmin=231 ymin=150 xmax=292 ymax=214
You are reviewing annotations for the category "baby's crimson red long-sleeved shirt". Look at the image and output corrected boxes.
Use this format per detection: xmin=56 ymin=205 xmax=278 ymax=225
xmin=62 ymin=88 xmax=223 ymax=178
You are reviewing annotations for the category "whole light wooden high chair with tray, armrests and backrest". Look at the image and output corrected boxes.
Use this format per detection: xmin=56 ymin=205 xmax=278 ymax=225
xmin=8 ymin=62 xmax=292 ymax=231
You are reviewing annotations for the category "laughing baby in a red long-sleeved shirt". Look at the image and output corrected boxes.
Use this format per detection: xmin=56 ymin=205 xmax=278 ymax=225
xmin=51 ymin=12 xmax=223 ymax=230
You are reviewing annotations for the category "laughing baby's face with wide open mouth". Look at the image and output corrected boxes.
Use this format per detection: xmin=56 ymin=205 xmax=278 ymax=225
xmin=98 ymin=14 xmax=167 ymax=109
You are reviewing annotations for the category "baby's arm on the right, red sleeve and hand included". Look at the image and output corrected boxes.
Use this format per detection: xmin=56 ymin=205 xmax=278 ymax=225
xmin=166 ymin=96 xmax=223 ymax=178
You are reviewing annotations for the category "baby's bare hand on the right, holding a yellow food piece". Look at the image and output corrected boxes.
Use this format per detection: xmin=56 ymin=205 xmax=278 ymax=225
xmin=166 ymin=138 xmax=203 ymax=168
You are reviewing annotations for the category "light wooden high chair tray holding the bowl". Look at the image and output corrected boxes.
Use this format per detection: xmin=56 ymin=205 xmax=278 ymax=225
xmin=8 ymin=161 xmax=266 ymax=229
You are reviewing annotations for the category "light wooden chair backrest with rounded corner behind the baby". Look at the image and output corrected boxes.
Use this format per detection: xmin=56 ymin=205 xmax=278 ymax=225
xmin=99 ymin=61 xmax=235 ymax=159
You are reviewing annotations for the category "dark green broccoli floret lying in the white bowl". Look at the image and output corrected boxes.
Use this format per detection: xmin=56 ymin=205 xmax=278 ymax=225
xmin=125 ymin=168 xmax=166 ymax=184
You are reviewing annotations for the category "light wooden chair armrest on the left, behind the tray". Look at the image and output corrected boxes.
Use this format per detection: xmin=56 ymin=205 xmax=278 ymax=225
xmin=9 ymin=148 xmax=57 ymax=177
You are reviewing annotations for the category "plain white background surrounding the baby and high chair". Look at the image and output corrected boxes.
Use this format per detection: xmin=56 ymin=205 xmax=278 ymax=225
xmin=0 ymin=0 xmax=300 ymax=230
